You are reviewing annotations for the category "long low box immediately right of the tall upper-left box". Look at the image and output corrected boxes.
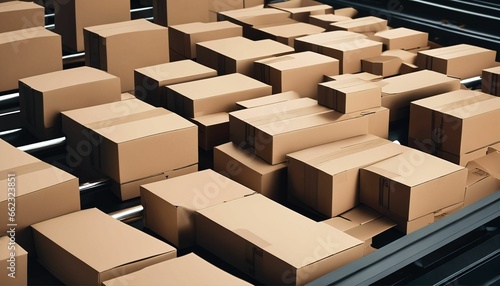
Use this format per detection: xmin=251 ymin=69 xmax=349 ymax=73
xmin=168 ymin=21 xmax=243 ymax=59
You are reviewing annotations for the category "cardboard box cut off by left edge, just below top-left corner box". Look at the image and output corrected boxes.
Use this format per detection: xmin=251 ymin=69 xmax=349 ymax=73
xmin=0 ymin=27 xmax=62 ymax=91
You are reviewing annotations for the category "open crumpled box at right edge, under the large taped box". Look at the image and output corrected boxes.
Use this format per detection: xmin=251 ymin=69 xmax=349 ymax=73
xmin=464 ymin=152 xmax=500 ymax=207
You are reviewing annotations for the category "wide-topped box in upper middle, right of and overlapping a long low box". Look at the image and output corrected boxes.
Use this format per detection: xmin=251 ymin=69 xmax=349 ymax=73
xmin=196 ymin=37 xmax=294 ymax=76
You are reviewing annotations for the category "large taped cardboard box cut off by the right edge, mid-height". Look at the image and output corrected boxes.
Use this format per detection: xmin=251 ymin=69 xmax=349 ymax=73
xmin=408 ymin=89 xmax=500 ymax=156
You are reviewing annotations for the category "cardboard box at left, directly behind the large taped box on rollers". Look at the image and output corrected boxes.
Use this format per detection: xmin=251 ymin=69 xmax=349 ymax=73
xmin=19 ymin=67 xmax=121 ymax=140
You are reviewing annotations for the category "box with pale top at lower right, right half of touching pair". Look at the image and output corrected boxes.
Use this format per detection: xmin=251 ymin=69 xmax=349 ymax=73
xmin=360 ymin=149 xmax=467 ymax=221
